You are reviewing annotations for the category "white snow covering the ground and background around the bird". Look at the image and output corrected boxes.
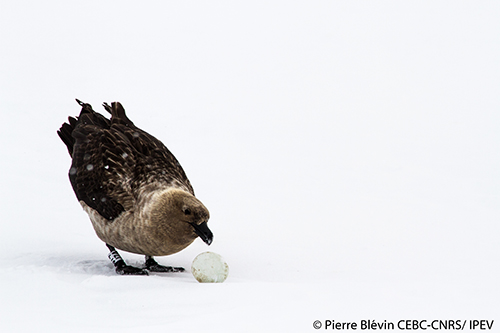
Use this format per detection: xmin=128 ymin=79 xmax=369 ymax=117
xmin=0 ymin=1 xmax=500 ymax=332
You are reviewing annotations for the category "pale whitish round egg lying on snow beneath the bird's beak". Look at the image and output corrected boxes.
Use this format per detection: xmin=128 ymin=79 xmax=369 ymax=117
xmin=191 ymin=252 xmax=229 ymax=283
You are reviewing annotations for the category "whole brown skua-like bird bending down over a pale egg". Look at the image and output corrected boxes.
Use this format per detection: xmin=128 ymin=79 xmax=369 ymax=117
xmin=57 ymin=100 xmax=213 ymax=275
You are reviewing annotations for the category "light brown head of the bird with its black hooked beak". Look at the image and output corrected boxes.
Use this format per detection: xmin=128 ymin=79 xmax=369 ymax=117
xmin=152 ymin=189 xmax=213 ymax=245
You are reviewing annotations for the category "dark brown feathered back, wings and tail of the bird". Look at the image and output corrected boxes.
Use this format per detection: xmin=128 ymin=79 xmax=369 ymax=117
xmin=60 ymin=102 xmax=194 ymax=220
